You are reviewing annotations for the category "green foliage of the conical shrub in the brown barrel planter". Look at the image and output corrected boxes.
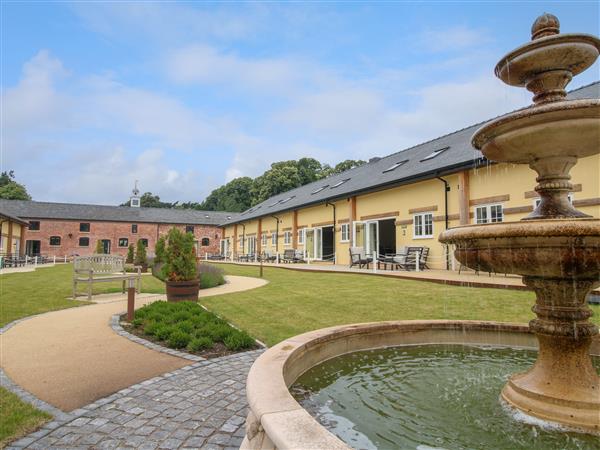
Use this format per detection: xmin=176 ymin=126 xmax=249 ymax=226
xmin=162 ymin=228 xmax=197 ymax=281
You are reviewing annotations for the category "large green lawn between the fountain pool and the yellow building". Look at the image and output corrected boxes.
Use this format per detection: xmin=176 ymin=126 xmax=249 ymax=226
xmin=200 ymin=264 xmax=600 ymax=345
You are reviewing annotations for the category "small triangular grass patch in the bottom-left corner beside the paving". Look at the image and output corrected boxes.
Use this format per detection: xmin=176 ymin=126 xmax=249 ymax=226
xmin=0 ymin=388 xmax=52 ymax=448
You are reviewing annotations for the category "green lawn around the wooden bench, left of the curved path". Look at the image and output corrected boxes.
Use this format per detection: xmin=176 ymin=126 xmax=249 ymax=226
xmin=0 ymin=264 xmax=165 ymax=326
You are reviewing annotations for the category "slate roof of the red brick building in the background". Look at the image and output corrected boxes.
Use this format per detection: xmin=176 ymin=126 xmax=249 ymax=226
xmin=0 ymin=200 xmax=239 ymax=225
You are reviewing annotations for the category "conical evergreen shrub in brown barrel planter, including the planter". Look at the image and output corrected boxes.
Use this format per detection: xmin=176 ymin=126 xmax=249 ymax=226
xmin=162 ymin=228 xmax=200 ymax=302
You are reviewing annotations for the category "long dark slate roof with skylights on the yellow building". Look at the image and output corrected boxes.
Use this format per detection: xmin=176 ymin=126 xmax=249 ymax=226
xmin=230 ymin=81 xmax=600 ymax=223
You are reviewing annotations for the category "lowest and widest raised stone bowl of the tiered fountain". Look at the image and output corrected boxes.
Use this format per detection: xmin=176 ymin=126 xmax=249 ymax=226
xmin=440 ymin=219 xmax=600 ymax=280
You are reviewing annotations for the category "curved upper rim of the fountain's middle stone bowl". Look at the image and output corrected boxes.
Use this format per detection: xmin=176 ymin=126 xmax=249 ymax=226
xmin=471 ymin=98 xmax=600 ymax=150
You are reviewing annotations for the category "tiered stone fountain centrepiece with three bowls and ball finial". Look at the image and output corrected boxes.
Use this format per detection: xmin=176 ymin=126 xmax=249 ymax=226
xmin=440 ymin=14 xmax=600 ymax=431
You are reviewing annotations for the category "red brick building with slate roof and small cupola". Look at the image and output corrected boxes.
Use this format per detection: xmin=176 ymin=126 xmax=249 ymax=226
xmin=0 ymin=198 xmax=238 ymax=257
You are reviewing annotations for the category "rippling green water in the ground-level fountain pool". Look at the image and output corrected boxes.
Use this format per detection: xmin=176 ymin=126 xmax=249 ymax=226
xmin=290 ymin=345 xmax=600 ymax=450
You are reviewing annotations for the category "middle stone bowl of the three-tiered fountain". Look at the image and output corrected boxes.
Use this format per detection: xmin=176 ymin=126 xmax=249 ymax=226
xmin=472 ymin=99 xmax=600 ymax=164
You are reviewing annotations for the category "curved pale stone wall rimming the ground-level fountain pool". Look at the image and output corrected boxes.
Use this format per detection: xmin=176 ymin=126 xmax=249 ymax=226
xmin=242 ymin=320 xmax=600 ymax=449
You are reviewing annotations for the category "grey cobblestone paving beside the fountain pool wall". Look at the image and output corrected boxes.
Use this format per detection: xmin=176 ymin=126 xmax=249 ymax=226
xmin=11 ymin=350 xmax=263 ymax=450
